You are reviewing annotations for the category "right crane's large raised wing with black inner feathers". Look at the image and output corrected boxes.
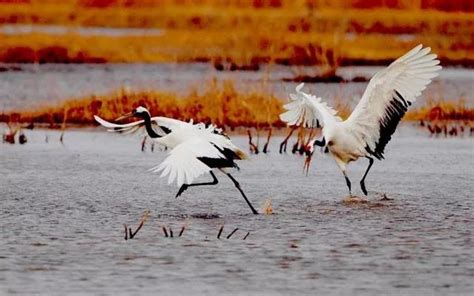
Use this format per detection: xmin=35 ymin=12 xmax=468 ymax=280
xmin=344 ymin=44 xmax=441 ymax=159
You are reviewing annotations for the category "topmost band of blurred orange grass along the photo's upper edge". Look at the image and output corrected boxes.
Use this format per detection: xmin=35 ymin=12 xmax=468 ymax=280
xmin=0 ymin=1 xmax=474 ymax=34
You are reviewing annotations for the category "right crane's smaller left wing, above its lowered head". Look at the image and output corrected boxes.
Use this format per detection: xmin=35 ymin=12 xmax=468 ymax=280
xmin=280 ymin=83 xmax=341 ymax=128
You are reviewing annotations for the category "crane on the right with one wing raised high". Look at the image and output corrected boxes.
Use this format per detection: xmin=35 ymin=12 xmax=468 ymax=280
xmin=280 ymin=44 xmax=441 ymax=195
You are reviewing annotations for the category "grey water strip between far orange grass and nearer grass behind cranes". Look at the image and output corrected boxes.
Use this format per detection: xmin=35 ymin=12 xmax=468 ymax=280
xmin=0 ymin=63 xmax=474 ymax=111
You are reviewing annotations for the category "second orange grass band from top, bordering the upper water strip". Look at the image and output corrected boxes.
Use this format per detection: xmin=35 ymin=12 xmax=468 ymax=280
xmin=0 ymin=30 xmax=474 ymax=67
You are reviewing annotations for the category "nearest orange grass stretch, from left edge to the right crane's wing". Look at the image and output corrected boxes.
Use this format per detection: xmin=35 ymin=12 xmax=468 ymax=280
xmin=0 ymin=81 xmax=283 ymax=128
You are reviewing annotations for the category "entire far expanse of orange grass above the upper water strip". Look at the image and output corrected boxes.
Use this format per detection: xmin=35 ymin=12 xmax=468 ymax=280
xmin=0 ymin=1 xmax=474 ymax=65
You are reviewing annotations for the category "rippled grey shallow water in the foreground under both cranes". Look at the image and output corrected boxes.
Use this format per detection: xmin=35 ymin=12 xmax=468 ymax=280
xmin=0 ymin=126 xmax=474 ymax=295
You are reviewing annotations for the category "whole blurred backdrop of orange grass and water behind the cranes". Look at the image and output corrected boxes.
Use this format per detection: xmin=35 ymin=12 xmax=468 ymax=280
xmin=0 ymin=0 xmax=474 ymax=130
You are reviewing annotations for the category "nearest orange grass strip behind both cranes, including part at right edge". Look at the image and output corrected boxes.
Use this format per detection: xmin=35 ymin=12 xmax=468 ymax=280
xmin=0 ymin=80 xmax=474 ymax=128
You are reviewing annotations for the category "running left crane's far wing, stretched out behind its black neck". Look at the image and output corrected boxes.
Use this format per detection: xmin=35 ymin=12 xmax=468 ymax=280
xmin=94 ymin=115 xmax=188 ymax=136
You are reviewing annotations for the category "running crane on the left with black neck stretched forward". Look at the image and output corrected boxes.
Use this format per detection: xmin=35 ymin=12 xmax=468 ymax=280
xmin=94 ymin=107 xmax=258 ymax=214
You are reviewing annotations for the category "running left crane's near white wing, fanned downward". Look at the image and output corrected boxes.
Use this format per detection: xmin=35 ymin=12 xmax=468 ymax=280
xmin=151 ymin=137 xmax=225 ymax=186
